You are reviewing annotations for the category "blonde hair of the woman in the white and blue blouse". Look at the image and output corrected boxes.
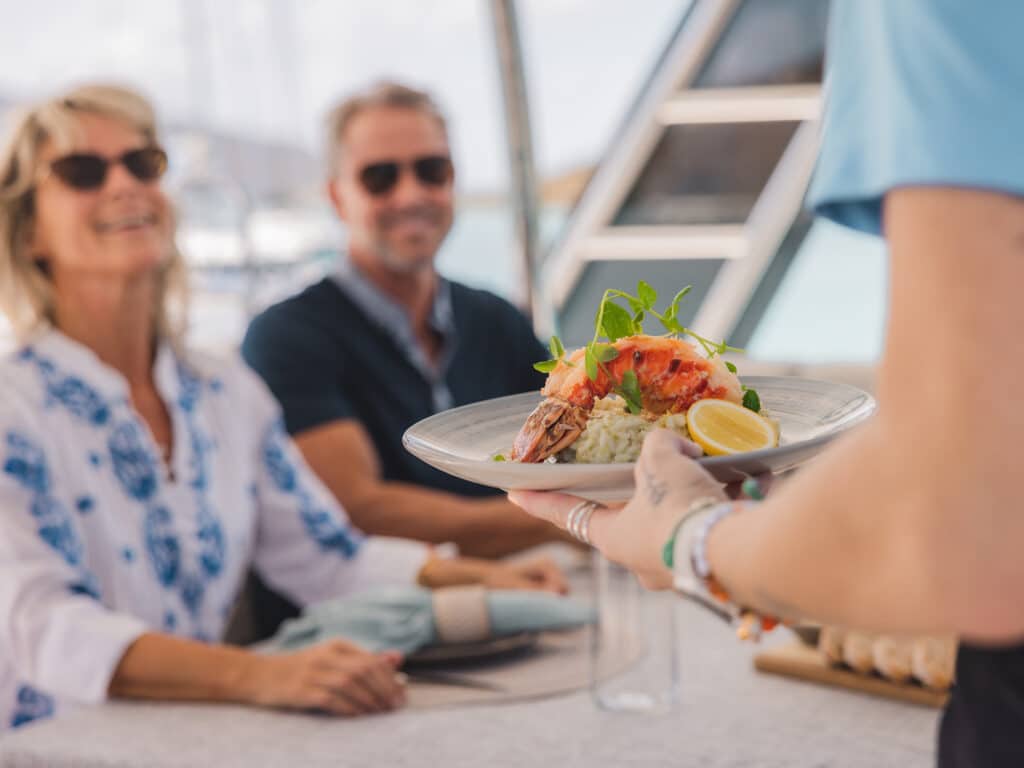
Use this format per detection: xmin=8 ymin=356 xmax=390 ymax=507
xmin=0 ymin=85 xmax=187 ymax=342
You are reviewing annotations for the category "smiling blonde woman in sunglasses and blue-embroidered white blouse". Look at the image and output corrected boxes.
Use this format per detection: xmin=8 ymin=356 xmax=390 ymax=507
xmin=0 ymin=86 xmax=562 ymax=728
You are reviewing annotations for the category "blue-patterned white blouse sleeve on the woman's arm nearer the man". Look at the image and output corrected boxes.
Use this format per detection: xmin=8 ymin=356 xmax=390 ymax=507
xmin=240 ymin=370 xmax=428 ymax=605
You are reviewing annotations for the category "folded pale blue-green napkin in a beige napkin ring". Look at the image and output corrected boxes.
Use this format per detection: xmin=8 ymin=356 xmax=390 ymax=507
xmin=264 ymin=587 xmax=596 ymax=653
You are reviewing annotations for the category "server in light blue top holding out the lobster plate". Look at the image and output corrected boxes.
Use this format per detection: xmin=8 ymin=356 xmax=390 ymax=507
xmin=513 ymin=0 xmax=1024 ymax=768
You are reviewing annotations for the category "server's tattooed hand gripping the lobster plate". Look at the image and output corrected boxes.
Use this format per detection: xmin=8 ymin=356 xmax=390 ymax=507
xmin=509 ymin=429 xmax=728 ymax=589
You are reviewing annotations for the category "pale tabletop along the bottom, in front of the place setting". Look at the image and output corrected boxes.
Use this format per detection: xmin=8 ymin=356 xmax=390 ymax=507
xmin=0 ymin=606 xmax=938 ymax=768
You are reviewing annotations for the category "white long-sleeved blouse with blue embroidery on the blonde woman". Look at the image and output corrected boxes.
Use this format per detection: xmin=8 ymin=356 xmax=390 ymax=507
xmin=0 ymin=330 xmax=426 ymax=730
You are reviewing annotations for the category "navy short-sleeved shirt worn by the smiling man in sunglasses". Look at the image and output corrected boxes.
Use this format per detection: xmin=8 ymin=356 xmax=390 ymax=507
xmin=242 ymin=264 xmax=549 ymax=496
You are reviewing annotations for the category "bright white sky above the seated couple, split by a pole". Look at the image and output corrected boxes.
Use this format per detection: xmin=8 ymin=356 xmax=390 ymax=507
xmin=0 ymin=0 xmax=689 ymax=190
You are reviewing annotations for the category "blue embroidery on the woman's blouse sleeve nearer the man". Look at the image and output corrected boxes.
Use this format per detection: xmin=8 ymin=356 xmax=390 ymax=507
xmin=262 ymin=419 xmax=362 ymax=558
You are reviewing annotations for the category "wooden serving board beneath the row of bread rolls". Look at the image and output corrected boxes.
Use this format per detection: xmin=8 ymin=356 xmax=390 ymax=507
xmin=754 ymin=642 xmax=949 ymax=708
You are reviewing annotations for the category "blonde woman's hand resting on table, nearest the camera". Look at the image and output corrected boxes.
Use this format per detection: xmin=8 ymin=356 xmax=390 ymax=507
xmin=245 ymin=640 xmax=406 ymax=717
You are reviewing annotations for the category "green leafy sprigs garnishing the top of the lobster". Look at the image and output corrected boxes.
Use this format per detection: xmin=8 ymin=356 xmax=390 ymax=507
xmin=534 ymin=281 xmax=761 ymax=414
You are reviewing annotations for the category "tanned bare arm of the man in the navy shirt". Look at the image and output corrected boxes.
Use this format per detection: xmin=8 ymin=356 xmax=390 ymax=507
xmin=295 ymin=419 xmax=564 ymax=557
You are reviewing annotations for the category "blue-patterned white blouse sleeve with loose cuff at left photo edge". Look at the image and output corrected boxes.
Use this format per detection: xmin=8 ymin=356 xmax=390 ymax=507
xmin=0 ymin=414 xmax=150 ymax=703
